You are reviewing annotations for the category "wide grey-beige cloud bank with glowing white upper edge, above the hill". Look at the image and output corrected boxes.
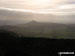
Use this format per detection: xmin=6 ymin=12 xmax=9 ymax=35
xmin=0 ymin=4 xmax=75 ymax=23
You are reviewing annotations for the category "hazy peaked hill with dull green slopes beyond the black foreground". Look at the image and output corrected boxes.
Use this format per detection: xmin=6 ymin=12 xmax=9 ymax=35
xmin=0 ymin=21 xmax=75 ymax=38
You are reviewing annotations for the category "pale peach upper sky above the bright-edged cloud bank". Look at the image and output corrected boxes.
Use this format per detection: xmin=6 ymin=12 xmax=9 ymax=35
xmin=0 ymin=0 xmax=75 ymax=10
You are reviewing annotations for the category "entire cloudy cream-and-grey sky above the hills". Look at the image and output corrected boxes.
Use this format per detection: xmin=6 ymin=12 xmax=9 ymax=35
xmin=0 ymin=0 xmax=75 ymax=23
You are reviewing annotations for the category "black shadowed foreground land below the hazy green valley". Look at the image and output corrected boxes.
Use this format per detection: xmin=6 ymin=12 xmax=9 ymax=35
xmin=0 ymin=30 xmax=75 ymax=56
